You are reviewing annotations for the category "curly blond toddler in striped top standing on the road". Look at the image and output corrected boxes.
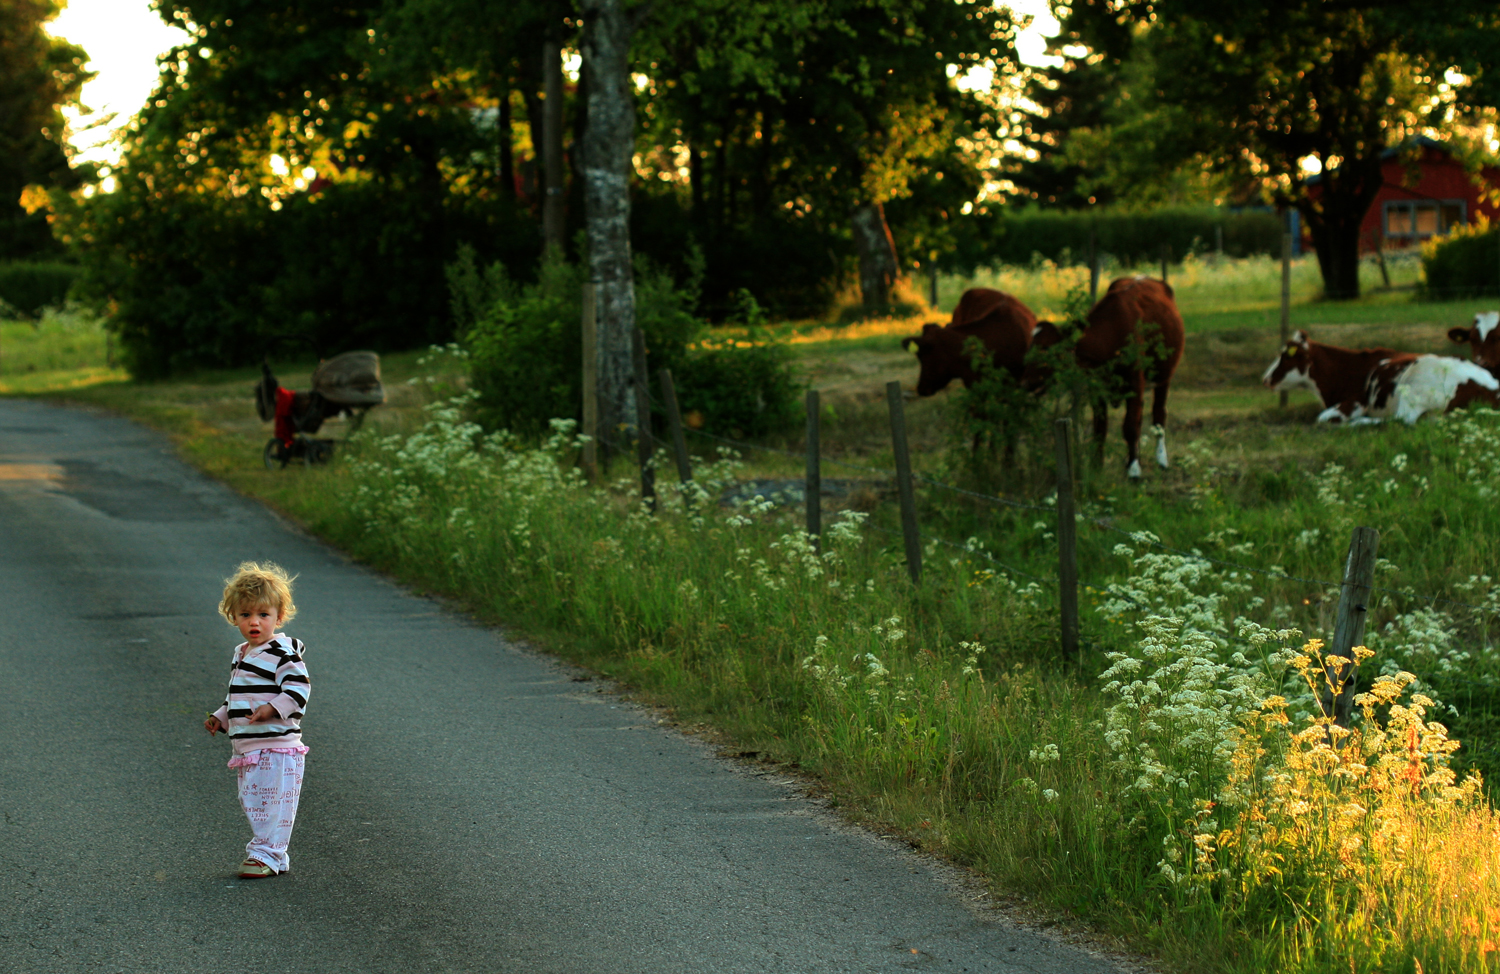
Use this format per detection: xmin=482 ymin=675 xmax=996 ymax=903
xmin=203 ymin=561 xmax=312 ymax=879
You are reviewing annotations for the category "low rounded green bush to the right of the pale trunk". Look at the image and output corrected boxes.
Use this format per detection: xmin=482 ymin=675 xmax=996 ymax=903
xmin=674 ymin=341 xmax=803 ymax=440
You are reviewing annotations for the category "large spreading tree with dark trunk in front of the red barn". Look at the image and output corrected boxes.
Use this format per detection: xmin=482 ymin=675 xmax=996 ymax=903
xmin=1067 ymin=0 xmax=1500 ymax=299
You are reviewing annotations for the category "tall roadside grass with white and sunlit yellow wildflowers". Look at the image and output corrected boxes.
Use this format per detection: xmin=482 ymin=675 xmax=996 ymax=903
xmin=289 ymin=351 xmax=1500 ymax=971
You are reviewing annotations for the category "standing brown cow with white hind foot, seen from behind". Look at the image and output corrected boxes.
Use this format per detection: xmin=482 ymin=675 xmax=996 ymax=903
xmin=1022 ymin=278 xmax=1185 ymax=479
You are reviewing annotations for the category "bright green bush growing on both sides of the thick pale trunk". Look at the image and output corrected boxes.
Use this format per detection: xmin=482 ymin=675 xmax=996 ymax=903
xmin=465 ymin=251 xmax=702 ymax=437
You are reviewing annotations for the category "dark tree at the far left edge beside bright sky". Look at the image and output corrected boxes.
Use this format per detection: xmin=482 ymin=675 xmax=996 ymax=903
xmin=0 ymin=0 xmax=93 ymax=260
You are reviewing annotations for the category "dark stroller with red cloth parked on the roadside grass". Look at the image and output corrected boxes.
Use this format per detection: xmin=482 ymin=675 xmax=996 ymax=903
xmin=255 ymin=351 xmax=386 ymax=470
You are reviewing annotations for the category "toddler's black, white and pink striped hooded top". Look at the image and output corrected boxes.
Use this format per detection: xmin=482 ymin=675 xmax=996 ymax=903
xmin=213 ymin=633 xmax=312 ymax=755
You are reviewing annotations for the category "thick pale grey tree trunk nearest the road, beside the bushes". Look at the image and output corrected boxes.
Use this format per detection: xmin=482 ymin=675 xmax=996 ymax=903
xmin=579 ymin=0 xmax=636 ymax=471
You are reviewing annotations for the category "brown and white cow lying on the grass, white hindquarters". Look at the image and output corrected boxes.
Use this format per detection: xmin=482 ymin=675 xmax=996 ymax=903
xmin=1262 ymin=330 xmax=1500 ymax=425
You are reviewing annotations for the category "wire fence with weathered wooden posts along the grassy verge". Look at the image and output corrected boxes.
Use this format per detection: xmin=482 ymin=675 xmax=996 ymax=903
xmin=588 ymin=360 xmax=1500 ymax=711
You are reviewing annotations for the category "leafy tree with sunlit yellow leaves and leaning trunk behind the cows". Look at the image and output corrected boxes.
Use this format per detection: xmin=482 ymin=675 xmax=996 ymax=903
xmin=644 ymin=0 xmax=1011 ymax=311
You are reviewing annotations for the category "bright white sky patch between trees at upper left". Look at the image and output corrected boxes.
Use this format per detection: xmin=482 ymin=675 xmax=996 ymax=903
xmin=48 ymin=0 xmax=188 ymax=162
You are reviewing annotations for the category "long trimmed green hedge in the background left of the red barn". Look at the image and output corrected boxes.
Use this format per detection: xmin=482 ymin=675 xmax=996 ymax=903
xmin=990 ymin=207 xmax=1281 ymax=266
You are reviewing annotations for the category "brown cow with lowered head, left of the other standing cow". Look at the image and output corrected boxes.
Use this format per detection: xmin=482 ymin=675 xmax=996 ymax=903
xmin=902 ymin=288 xmax=1037 ymax=396
